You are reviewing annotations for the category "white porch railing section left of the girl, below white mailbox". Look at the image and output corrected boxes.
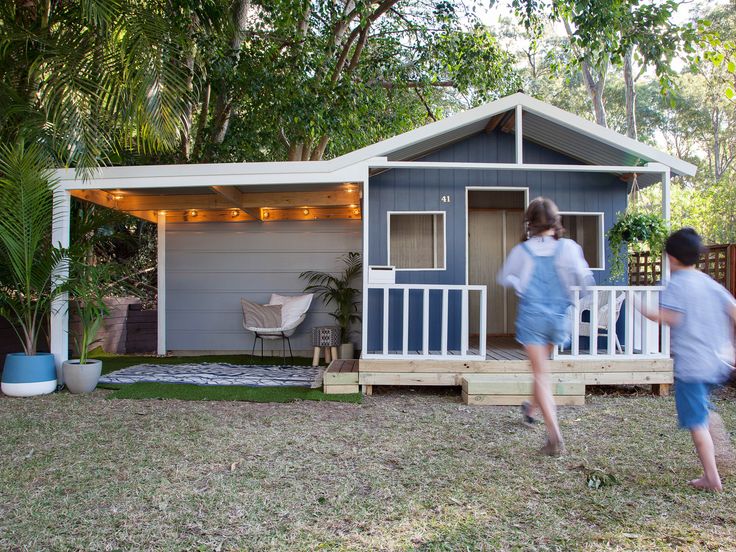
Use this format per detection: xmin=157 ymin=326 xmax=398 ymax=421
xmin=363 ymin=284 xmax=487 ymax=360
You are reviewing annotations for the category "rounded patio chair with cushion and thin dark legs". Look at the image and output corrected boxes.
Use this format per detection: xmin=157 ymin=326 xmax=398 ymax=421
xmin=240 ymin=293 xmax=314 ymax=361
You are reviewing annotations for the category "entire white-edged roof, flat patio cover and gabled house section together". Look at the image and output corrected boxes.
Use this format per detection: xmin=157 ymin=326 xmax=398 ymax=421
xmin=57 ymin=93 xmax=696 ymax=189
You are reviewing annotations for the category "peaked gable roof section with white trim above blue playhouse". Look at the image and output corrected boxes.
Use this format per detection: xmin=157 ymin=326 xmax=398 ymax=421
xmin=331 ymin=93 xmax=696 ymax=182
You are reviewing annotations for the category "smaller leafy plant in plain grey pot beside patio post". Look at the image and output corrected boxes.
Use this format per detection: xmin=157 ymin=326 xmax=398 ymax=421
xmin=62 ymin=261 xmax=115 ymax=393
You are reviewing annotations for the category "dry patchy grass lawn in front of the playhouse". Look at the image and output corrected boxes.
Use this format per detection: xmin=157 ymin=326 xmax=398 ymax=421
xmin=0 ymin=388 xmax=736 ymax=551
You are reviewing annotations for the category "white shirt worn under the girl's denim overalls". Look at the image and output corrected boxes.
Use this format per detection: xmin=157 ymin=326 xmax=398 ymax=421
xmin=497 ymin=236 xmax=595 ymax=298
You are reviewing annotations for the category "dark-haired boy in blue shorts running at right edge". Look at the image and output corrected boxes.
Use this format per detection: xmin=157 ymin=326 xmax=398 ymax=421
xmin=640 ymin=228 xmax=736 ymax=491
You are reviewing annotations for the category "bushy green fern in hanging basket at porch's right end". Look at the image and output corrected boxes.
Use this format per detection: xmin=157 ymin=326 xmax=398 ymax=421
xmin=607 ymin=211 xmax=668 ymax=280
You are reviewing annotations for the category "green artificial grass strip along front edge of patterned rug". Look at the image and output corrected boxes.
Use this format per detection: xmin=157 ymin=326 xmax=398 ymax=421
xmin=100 ymin=382 xmax=363 ymax=404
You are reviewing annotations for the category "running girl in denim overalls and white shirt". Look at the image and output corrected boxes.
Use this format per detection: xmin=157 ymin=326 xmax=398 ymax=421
xmin=498 ymin=197 xmax=593 ymax=456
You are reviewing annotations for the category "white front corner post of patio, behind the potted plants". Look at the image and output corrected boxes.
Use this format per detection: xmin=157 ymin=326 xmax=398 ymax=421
xmin=49 ymin=188 xmax=72 ymax=385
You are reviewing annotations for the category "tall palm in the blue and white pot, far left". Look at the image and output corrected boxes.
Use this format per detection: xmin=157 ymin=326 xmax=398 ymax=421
xmin=0 ymin=142 xmax=66 ymax=397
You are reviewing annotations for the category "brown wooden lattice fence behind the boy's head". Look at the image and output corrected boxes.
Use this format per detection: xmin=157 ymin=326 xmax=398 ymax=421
xmin=629 ymin=244 xmax=736 ymax=295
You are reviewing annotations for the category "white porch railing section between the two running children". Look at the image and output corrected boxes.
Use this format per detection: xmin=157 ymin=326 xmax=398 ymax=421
xmin=554 ymin=286 xmax=670 ymax=359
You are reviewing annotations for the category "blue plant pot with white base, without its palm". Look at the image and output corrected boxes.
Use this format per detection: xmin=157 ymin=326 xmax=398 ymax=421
xmin=2 ymin=353 xmax=56 ymax=397
